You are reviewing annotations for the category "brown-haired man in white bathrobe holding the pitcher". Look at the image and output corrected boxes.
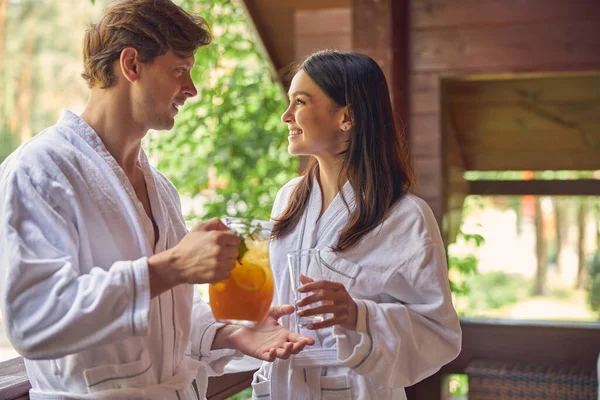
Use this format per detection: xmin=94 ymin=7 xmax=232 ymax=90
xmin=0 ymin=0 xmax=314 ymax=399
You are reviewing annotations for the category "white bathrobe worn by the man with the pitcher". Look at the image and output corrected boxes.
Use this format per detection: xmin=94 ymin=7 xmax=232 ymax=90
xmin=0 ymin=110 xmax=239 ymax=399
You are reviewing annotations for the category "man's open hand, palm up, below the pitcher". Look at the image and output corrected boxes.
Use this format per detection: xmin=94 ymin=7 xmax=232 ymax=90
xmin=213 ymin=305 xmax=315 ymax=361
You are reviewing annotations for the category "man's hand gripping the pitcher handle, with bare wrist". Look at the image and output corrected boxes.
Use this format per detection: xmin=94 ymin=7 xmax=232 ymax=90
xmin=148 ymin=218 xmax=240 ymax=297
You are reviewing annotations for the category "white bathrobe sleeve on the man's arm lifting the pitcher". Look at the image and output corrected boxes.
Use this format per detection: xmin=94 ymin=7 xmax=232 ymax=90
xmin=0 ymin=168 xmax=150 ymax=359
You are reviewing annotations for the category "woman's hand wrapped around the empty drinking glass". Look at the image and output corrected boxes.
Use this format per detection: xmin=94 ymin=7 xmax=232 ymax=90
xmin=296 ymin=275 xmax=357 ymax=331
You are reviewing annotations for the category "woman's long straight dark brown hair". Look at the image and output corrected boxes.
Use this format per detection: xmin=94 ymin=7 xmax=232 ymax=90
xmin=273 ymin=50 xmax=414 ymax=252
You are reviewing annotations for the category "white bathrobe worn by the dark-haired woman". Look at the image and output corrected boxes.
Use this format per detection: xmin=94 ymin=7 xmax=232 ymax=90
xmin=252 ymin=178 xmax=461 ymax=400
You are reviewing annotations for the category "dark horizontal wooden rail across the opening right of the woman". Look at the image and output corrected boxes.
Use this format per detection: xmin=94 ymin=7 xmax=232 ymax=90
xmin=468 ymin=179 xmax=600 ymax=196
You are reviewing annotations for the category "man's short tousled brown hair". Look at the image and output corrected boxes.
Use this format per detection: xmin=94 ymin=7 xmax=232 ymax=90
xmin=81 ymin=0 xmax=211 ymax=89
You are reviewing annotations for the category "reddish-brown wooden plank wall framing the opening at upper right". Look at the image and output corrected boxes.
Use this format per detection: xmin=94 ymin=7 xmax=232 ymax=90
xmin=410 ymin=0 xmax=600 ymax=225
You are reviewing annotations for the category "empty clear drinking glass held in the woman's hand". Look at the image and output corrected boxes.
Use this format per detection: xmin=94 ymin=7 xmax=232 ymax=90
xmin=287 ymin=249 xmax=324 ymax=327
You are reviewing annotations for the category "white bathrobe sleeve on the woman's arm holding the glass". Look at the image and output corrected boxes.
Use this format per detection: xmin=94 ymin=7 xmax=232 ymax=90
xmin=333 ymin=203 xmax=461 ymax=387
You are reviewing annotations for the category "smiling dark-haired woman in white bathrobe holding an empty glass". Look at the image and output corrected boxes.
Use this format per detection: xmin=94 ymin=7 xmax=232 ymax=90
xmin=252 ymin=51 xmax=461 ymax=400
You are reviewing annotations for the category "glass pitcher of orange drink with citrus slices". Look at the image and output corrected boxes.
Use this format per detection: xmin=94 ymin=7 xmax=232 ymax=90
xmin=208 ymin=217 xmax=274 ymax=327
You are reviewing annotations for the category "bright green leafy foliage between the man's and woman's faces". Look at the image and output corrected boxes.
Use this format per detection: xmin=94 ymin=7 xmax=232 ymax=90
xmin=147 ymin=0 xmax=298 ymax=219
